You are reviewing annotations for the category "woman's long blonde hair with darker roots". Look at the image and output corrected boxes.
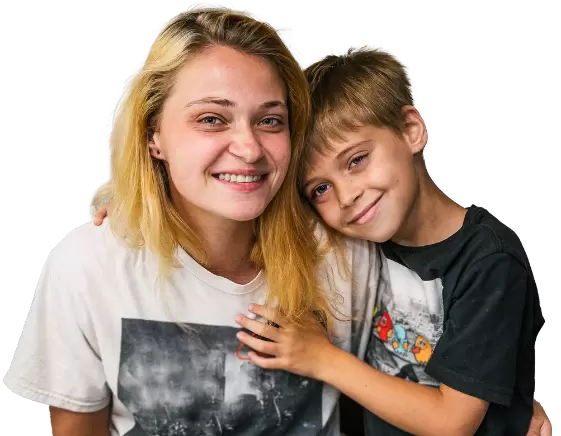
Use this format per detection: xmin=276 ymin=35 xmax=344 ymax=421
xmin=90 ymin=3 xmax=332 ymax=325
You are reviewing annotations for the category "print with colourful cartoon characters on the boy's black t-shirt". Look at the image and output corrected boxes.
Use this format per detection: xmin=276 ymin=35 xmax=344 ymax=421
xmin=366 ymin=255 xmax=443 ymax=386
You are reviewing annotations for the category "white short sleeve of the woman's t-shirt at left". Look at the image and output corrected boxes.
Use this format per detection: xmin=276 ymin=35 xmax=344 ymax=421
xmin=3 ymin=249 xmax=110 ymax=412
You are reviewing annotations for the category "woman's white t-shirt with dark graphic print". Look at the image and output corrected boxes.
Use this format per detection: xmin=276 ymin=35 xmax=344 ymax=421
xmin=3 ymin=220 xmax=379 ymax=436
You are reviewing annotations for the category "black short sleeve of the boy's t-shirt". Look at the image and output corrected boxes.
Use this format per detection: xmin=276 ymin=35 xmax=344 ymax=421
xmin=426 ymin=253 xmax=532 ymax=406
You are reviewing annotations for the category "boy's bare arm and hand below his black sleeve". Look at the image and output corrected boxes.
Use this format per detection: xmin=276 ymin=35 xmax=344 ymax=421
xmin=236 ymin=304 xmax=487 ymax=436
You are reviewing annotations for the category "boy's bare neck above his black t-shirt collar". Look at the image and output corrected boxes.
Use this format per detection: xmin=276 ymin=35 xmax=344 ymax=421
xmin=391 ymin=166 xmax=467 ymax=247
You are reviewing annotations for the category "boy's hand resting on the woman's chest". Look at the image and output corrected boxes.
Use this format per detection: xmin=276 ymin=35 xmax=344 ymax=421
xmin=236 ymin=304 xmax=334 ymax=378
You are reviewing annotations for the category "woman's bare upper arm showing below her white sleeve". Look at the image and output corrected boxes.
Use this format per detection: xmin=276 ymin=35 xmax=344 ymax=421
xmin=49 ymin=406 xmax=110 ymax=436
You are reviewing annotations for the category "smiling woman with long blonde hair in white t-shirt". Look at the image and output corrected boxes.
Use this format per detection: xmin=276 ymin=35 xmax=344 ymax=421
xmin=4 ymin=3 xmax=377 ymax=436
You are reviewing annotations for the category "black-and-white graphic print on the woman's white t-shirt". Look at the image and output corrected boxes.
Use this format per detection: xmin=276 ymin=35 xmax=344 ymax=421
xmin=117 ymin=319 xmax=322 ymax=436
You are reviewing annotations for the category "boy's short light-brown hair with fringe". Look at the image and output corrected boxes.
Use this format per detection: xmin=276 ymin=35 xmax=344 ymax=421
xmin=298 ymin=42 xmax=420 ymax=242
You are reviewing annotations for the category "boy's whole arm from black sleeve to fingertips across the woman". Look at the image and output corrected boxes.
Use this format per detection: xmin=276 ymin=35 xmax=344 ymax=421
xmin=234 ymin=253 xmax=533 ymax=435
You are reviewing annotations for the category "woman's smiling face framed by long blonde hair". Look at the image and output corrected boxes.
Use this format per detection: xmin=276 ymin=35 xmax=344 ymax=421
xmin=149 ymin=46 xmax=290 ymax=224
